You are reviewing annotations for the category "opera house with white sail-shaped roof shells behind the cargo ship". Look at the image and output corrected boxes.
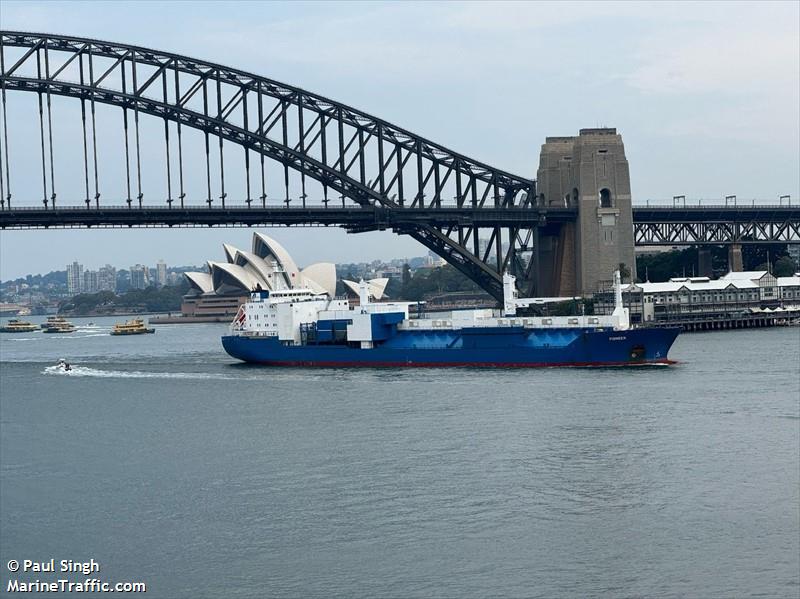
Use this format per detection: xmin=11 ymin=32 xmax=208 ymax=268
xmin=181 ymin=233 xmax=388 ymax=319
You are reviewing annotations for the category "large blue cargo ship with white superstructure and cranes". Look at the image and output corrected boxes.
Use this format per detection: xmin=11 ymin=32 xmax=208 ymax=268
xmin=222 ymin=272 xmax=680 ymax=367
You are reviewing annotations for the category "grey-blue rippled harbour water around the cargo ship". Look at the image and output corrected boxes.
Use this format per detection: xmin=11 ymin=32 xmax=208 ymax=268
xmin=0 ymin=319 xmax=800 ymax=599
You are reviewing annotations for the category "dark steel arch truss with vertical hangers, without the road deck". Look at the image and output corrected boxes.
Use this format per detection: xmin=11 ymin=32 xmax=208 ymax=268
xmin=0 ymin=32 xmax=539 ymax=297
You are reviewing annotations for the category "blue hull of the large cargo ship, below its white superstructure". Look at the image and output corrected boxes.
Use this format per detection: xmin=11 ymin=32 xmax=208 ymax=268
xmin=222 ymin=327 xmax=680 ymax=368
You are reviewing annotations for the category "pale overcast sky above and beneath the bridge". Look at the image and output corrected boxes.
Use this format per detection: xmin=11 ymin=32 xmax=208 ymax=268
xmin=0 ymin=0 xmax=800 ymax=279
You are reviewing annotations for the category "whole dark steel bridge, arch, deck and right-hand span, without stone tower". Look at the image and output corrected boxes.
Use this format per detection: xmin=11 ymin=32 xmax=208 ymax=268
xmin=0 ymin=31 xmax=800 ymax=299
